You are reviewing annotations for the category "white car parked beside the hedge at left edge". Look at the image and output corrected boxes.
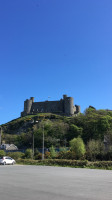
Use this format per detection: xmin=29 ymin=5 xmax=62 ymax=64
xmin=0 ymin=156 xmax=16 ymax=165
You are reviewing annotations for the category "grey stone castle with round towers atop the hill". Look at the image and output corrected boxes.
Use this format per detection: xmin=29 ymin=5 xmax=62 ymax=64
xmin=21 ymin=95 xmax=80 ymax=117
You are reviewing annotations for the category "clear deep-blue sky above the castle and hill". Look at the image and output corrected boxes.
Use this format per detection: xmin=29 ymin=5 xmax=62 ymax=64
xmin=0 ymin=0 xmax=112 ymax=124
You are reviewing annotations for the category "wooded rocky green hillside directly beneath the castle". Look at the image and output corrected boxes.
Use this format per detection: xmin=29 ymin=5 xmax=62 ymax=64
xmin=2 ymin=107 xmax=112 ymax=148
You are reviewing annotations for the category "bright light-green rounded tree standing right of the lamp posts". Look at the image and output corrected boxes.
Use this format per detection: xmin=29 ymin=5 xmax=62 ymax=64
xmin=70 ymin=137 xmax=86 ymax=159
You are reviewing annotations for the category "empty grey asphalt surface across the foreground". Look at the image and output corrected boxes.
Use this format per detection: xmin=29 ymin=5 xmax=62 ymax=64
xmin=0 ymin=165 xmax=112 ymax=200
